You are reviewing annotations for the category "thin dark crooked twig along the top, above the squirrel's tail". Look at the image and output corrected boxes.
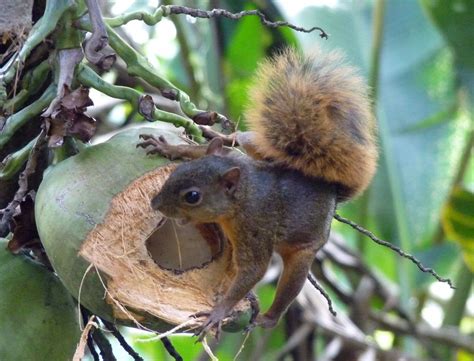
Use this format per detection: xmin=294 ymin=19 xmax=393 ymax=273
xmin=163 ymin=5 xmax=329 ymax=39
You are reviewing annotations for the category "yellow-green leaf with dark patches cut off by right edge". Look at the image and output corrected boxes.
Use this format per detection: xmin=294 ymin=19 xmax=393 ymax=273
xmin=442 ymin=187 xmax=474 ymax=272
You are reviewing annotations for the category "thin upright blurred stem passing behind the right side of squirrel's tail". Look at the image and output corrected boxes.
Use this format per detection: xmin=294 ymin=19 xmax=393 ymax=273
xmin=357 ymin=0 xmax=385 ymax=250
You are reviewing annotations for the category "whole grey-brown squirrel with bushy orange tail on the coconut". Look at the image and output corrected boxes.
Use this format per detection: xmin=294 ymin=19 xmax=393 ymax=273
xmin=137 ymin=49 xmax=377 ymax=338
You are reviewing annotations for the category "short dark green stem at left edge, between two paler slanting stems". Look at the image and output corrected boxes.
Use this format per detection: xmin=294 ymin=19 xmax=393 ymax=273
xmin=3 ymin=60 xmax=51 ymax=113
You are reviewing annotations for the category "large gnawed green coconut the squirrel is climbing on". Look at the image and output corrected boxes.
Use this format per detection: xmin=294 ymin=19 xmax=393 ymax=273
xmin=35 ymin=124 xmax=250 ymax=331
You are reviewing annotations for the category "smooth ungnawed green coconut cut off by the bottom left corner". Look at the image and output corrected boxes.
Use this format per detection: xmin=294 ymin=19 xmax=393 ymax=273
xmin=0 ymin=239 xmax=81 ymax=361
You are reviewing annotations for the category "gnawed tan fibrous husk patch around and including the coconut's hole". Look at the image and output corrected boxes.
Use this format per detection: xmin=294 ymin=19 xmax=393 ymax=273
xmin=79 ymin=164 xmax=250 ymax=324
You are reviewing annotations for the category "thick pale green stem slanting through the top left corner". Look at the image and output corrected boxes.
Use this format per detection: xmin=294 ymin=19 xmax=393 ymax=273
xmin=0 ymin=0 xmax=74 ymax=86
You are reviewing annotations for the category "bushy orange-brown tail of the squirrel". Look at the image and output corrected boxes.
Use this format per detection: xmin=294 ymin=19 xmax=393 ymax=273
xmin=246 ymin=49 xmax=377 ymax=199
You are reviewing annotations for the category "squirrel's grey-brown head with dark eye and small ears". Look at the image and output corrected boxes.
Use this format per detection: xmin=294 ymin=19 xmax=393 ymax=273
xmin=151 ymin=139 xmax=241 ymax=223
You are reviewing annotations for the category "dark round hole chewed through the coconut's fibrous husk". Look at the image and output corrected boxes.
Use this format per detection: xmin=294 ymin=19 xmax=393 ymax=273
xmin=146 ymin=218 xmax=223 ymax=273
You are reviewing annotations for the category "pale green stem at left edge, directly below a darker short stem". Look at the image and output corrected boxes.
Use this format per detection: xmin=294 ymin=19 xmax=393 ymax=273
xmin=0 ymin=84 xmax=56 ymax=149
